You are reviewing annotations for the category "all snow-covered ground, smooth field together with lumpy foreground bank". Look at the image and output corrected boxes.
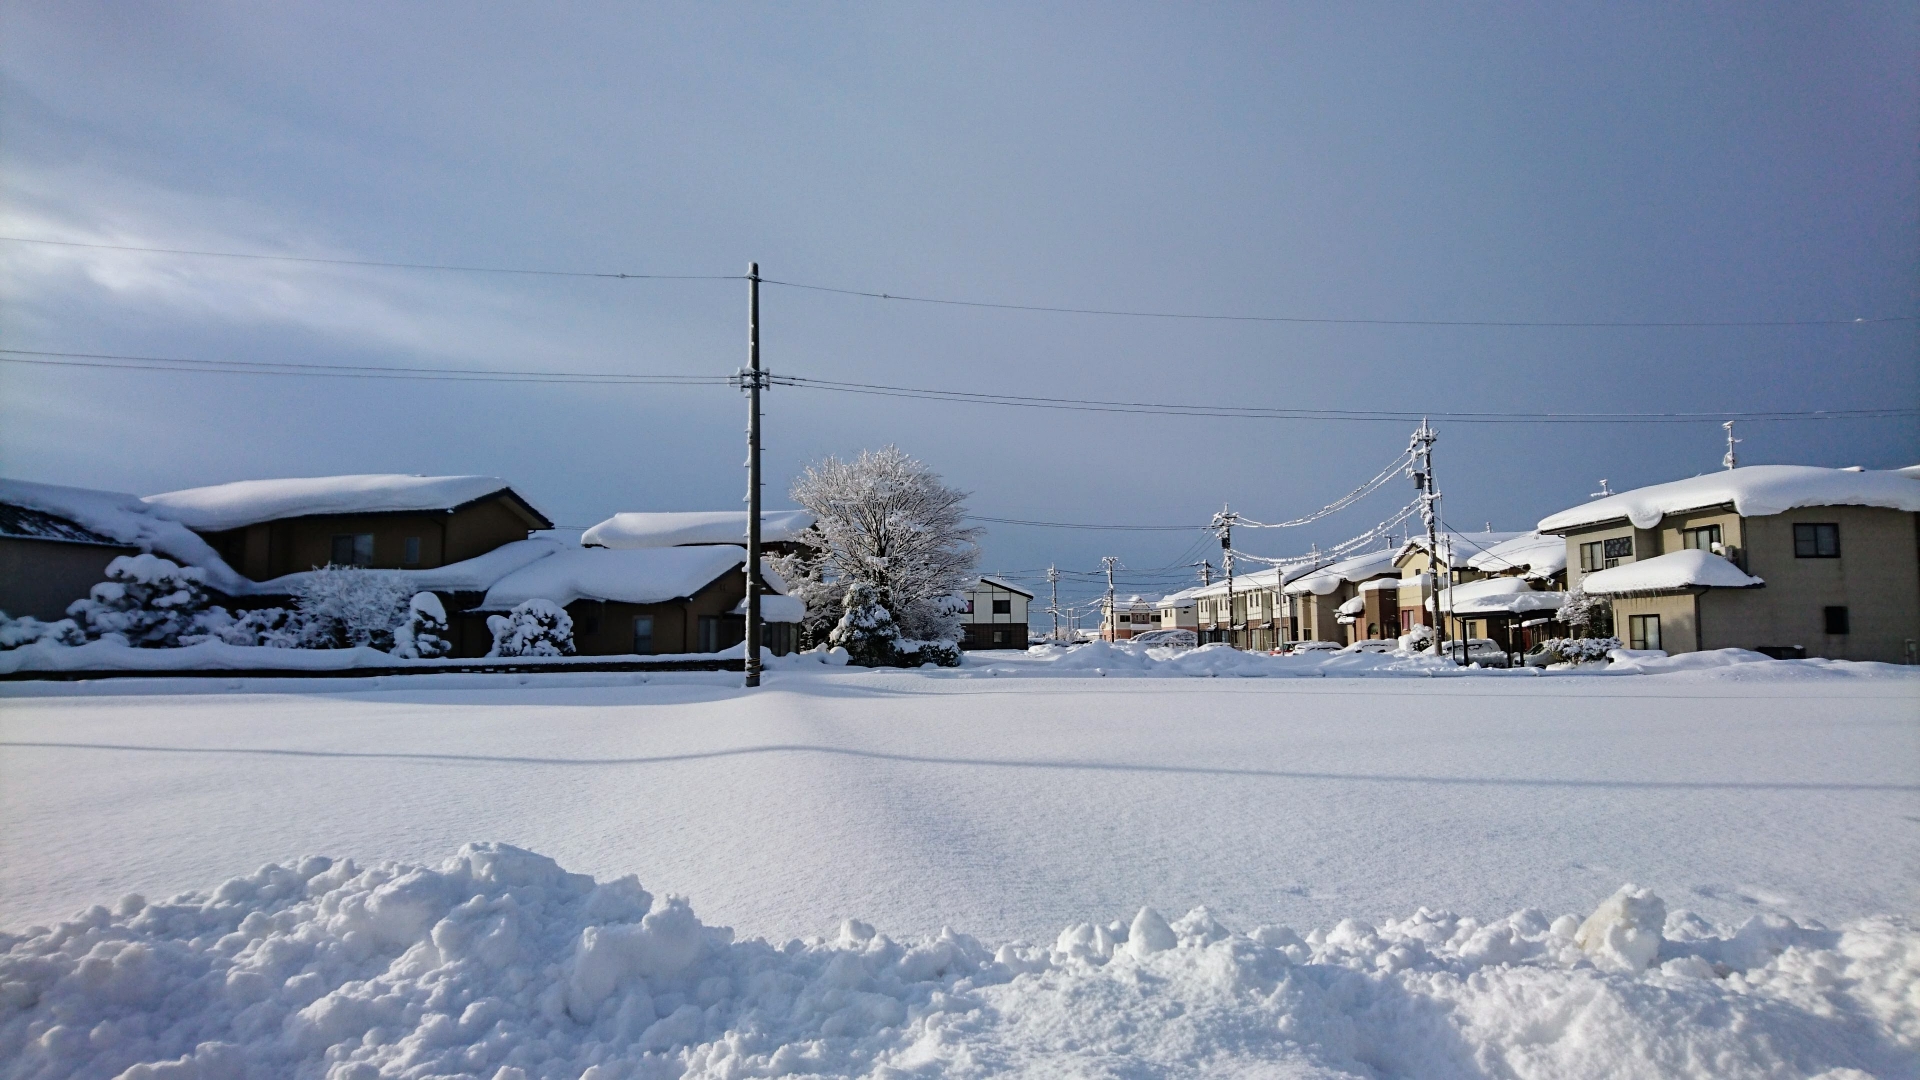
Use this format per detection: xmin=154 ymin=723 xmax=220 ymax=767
xmin=0 ymin=650 xmax=1920 ymax=1078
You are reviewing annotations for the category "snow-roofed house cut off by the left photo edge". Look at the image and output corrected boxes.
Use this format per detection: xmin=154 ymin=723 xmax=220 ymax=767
xmin=0 ymin=479 xmax=246 ymax=621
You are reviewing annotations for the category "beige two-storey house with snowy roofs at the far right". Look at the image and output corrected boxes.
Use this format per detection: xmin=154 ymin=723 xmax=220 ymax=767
xmin=1540 ymin=465 xmax=1920 ymax=663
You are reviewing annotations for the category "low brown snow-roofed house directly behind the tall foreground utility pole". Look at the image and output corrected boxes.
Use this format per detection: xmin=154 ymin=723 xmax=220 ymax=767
xmin=476 ymin=544 xmax=806 ymax=655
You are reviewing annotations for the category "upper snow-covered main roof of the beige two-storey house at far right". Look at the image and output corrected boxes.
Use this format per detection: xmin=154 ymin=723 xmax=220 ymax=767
xmin=1540 ymin=465 xmax=1920 ymax=532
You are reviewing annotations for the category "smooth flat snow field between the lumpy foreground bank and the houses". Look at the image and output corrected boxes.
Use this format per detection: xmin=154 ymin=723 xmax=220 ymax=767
xmin=0 ymin=665 xmax=1920 ymax=940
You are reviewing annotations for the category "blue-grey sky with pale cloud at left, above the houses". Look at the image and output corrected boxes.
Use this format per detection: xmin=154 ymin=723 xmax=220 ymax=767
xmin=0 ymin=0 xmax=1920 ymax=614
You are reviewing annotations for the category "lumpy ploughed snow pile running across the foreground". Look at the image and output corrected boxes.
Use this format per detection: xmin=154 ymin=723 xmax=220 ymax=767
xmin=0 ymin=844 xmax=1920 ymax=1080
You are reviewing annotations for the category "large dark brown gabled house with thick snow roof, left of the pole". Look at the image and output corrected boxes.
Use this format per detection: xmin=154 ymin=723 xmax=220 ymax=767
xmin=142 ymin=473 xmax=553 ymax=582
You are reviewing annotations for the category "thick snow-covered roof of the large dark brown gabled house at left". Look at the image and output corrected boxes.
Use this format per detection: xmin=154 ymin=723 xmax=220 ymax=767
xmin=144 ymin=473 xmax=553 ymax=532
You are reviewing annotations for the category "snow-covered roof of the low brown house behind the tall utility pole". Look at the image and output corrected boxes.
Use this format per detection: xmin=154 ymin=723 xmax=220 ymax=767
xmin=480 ymin=544 xmax=747 ymax=611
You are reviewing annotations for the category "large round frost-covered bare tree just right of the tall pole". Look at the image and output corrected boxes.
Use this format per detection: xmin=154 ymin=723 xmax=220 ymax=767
xmin=774 ymin=446 xmax=979 ymax=642
